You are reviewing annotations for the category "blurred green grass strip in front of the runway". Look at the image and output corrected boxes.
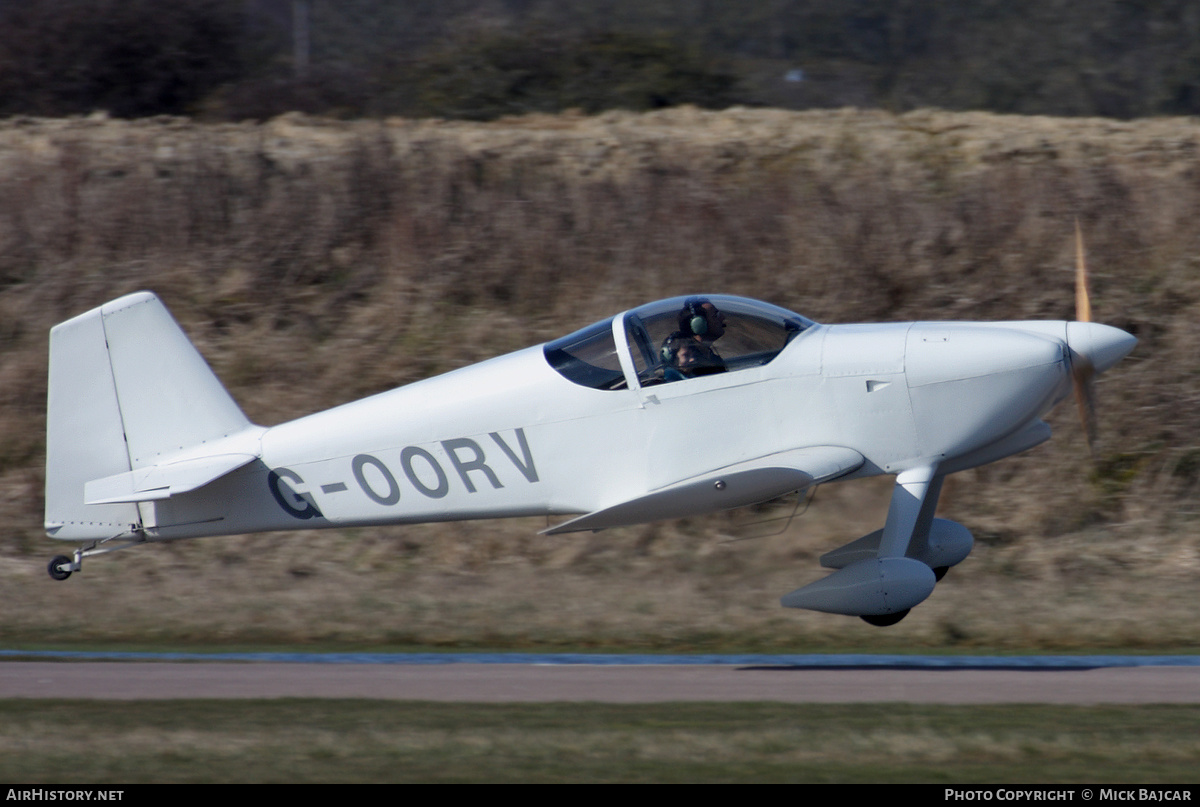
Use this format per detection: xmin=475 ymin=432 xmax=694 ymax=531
xmin=0 ymin=699 xmax=1200 ymax=784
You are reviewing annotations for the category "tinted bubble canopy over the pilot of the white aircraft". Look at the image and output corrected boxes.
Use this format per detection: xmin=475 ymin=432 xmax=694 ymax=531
xmin=544 ymin=294 xmax=815 ymax=390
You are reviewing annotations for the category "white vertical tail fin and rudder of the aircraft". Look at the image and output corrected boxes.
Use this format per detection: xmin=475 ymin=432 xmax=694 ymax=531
xmin=46 ymin=292 xmax=251 ymax=539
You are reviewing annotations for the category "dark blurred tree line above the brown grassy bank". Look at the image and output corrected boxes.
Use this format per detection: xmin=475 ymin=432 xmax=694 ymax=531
xmin=0 ymin=0 xmax=1200 ymax=119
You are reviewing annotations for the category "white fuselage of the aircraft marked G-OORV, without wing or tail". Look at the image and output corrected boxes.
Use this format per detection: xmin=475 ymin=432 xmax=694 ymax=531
xmin=142 ymin=323 xmax=1069 ymax=539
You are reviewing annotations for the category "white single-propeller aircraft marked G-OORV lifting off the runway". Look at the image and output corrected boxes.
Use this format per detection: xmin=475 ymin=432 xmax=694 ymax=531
xmin=46 ymin=256 xmax=1136 ymax=624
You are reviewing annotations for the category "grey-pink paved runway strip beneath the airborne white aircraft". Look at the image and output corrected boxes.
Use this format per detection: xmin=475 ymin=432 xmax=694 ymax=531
xmin=0 ymin=660 xmax=1200 ymax=705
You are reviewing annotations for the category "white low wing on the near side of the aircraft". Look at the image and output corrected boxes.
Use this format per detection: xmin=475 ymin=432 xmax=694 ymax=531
xmin=541 ymin=446 xmax=863 ymax=536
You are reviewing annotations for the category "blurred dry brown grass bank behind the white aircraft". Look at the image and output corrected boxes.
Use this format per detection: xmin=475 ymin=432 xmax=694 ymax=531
xmin=0 ymin=108 xmax=1200 ymax=646
